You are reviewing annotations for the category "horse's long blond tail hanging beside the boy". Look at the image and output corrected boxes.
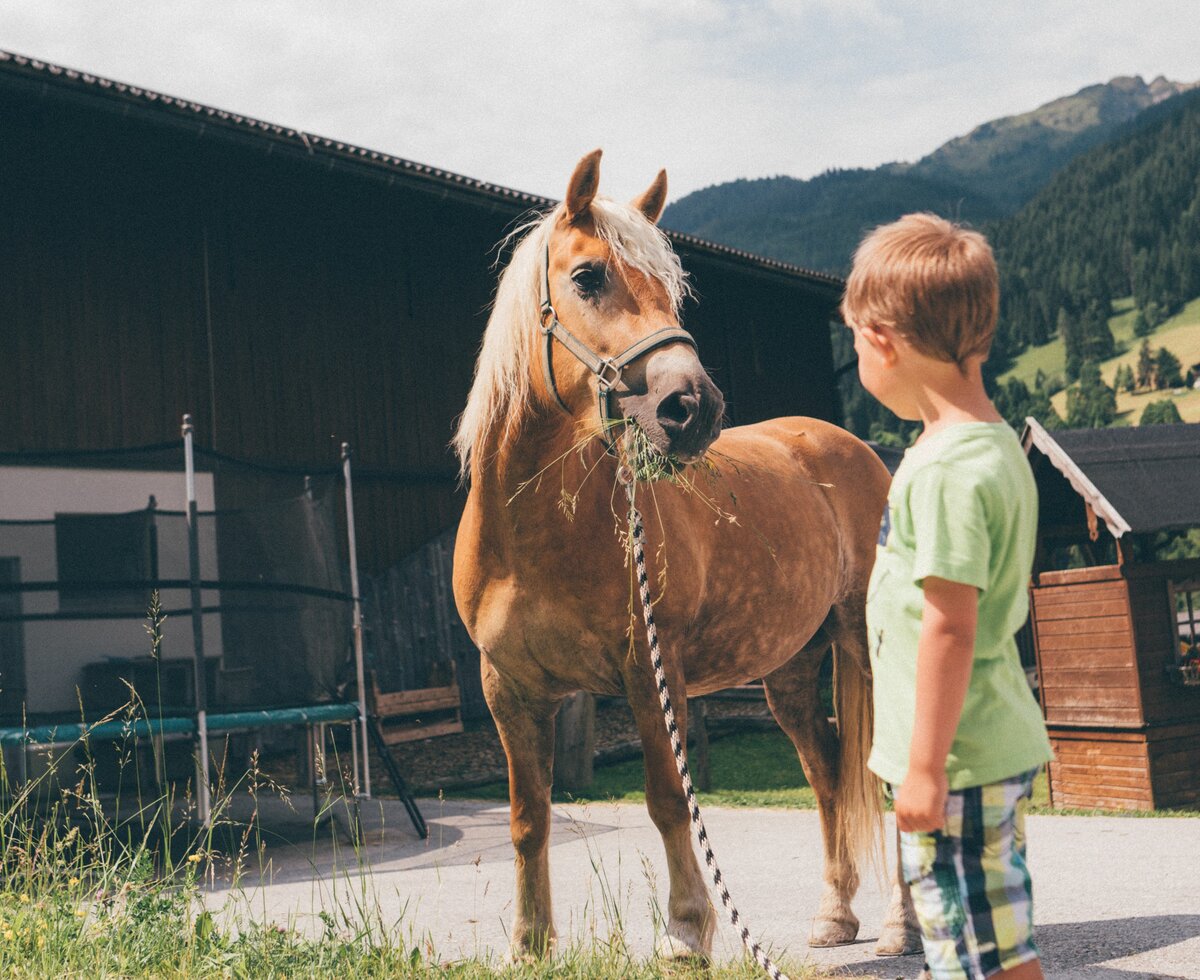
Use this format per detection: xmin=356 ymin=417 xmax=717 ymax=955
xmin=833 ymin=636 xmax=884 ymax=873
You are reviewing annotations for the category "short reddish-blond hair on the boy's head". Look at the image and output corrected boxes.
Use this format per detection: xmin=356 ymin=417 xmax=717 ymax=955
xmin=841 ymin=214 xmax=1000 ymax=368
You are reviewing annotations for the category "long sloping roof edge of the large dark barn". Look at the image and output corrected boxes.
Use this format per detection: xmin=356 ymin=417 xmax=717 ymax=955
xmin=0 ymin=49 xmax=845 ymax=297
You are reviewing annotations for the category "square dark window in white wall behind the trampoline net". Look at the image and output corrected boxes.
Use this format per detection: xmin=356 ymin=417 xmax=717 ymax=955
xmin=54 ymin=511 xmax=157 ymax=614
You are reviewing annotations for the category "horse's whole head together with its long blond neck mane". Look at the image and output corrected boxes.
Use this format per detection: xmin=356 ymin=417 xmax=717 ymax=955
xmin=454 ymin=150 xmax=725 ymax=473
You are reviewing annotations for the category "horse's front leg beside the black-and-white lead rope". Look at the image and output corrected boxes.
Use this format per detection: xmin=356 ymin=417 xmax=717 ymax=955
xmin=624 ymin=663 xmax=716 ymax=958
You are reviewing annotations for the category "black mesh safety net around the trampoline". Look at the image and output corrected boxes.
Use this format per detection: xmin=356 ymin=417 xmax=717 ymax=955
xmin=0 ymin=441 xmax=354 ymax=725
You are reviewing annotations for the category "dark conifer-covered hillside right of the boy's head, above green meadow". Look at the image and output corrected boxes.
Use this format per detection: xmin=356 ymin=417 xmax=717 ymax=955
xmin=988 ymin=92 xmax=1200 ymax=380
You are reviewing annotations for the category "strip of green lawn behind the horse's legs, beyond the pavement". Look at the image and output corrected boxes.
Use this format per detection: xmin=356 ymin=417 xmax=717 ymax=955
xmin=446 ymin=732 xmax=1200 ymax=817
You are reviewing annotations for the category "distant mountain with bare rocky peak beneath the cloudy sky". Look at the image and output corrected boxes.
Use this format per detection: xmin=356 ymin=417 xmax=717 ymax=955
xmin=662 ymin=77 xmax=1195 ymax=273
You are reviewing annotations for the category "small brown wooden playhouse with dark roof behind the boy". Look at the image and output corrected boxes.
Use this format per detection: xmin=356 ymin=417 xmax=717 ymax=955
xmin=1024 ymin=419 xmax=1200 ymax=810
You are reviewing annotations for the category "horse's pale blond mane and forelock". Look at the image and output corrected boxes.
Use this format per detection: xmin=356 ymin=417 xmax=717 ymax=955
xmin=451 ymin=197 xmax=690 ymax=477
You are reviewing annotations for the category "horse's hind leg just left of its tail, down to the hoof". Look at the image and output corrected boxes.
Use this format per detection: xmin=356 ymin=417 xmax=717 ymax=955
xmin=763 ymin=631 xmax=858 ymax=946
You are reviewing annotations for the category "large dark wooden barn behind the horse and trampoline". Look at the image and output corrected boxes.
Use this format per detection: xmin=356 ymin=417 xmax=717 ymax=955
xmin=0 ymin=52 xmax=841 ymax=719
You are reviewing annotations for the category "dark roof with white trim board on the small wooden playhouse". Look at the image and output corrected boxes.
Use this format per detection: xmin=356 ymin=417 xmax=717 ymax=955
xmin=1021 ymin=419 xmax=1200 ymax=537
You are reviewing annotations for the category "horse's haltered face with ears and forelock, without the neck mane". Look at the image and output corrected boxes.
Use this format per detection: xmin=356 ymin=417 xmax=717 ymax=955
xmin=536 ymin=150 xmax=725 ymax=462
